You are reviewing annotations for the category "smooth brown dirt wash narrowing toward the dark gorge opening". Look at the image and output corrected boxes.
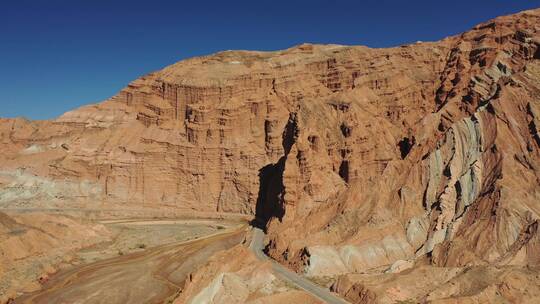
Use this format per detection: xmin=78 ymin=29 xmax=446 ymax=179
xmin=15 ymin=226 xmax=244 ymax=304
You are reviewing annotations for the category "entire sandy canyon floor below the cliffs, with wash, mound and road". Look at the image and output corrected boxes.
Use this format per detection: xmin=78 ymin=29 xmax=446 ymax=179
xmin=0 ymin=208 xmax=324 ymax=304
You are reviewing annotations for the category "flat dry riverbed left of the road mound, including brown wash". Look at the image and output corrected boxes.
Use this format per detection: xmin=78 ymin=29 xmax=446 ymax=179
xmin=0 ymin=213 xmax=245 ymax=303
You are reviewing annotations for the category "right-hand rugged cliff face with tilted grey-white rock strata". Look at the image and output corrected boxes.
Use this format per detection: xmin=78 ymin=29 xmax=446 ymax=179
xmin=269 ymin=11 xmax=540 ymax=275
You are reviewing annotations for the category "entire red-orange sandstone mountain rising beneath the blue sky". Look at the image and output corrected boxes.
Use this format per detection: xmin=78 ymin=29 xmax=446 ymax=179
xmin=0 ymin=10 xmax=540 ymax=302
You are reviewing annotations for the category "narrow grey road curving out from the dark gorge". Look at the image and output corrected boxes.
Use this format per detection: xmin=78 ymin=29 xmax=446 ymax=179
xmin=249 ymin=227 xmax=349 ymax=304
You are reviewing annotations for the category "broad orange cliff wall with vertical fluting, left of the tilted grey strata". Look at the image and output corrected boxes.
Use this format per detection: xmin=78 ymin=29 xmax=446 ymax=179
xmin=2 ymin=38 xmax=447 ymax=215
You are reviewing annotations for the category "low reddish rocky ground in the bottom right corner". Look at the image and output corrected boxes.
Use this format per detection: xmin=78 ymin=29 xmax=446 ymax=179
xmin=332 ymin=265 xmax=540 ymax=303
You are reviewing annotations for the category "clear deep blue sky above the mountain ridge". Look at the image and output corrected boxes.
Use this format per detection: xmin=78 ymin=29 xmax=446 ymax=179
xmin=0 ymin=0 xmax=540 ymax=119
